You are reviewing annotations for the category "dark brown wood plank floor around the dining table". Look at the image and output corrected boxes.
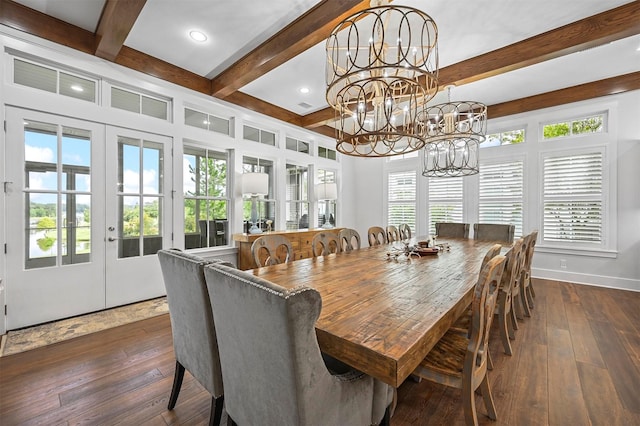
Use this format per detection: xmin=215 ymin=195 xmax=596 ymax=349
xmin=0 ymin=280 xmax=640 ymax=426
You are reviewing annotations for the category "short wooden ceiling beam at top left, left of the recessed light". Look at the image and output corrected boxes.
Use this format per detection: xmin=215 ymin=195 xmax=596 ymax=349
xmin=95 ymin=0 xmax=147 ymax=61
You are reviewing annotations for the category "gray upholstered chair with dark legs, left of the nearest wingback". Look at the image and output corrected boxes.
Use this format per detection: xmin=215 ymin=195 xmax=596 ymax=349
xmin=158 ymin=249 xmax=231 ymax=426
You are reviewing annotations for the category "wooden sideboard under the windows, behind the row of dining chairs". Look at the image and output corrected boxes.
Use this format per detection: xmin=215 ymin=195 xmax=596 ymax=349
xmin=233 ymin=228 xmax=343 ymax=270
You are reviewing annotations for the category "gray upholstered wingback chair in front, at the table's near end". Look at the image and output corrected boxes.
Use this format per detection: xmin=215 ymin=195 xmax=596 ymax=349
xmin=205 ymin=264 xmax=393 ymax=426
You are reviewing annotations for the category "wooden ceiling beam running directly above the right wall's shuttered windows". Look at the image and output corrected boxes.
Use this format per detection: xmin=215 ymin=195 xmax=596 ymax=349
xmin=487 ymin=71 xmax=640 ymax=119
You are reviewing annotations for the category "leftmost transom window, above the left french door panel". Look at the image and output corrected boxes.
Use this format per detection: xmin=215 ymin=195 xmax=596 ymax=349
xmin=13 ymin=59 xmax=96 ymax=102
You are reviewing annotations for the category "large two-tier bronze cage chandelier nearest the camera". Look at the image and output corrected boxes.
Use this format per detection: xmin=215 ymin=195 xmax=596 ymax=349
xmin=326 ymin=0 xmax=438 ymax=157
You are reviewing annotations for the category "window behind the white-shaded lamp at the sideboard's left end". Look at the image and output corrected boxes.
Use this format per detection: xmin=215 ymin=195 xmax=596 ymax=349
xmin=242 ymin=157 xmax=278 ymax=232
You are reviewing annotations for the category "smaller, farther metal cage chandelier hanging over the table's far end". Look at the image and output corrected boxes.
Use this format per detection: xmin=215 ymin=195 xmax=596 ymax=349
xmin=421 ymin=86 xmax=487 ymax=177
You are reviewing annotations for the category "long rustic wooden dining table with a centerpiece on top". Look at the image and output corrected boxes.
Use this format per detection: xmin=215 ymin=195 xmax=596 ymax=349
xmin=248 ymin=238 xmax=502 ymax=388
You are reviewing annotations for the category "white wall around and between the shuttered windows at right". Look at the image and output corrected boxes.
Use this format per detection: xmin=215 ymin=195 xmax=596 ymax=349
xmin=344 ymin=91 xmax=640 ymax=291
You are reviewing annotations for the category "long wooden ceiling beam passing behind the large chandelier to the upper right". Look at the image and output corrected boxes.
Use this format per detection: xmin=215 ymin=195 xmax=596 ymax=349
xmin=302 ymin=0 xmax=640 ymax=129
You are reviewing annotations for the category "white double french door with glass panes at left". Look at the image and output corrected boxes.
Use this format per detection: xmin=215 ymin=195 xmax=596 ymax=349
xmin=4 ymin=107 xmax=171 ymax=330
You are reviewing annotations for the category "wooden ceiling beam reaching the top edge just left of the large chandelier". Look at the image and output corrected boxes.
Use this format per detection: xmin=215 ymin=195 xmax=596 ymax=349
xmin=211 ymin=0 xmax=369 ymax=99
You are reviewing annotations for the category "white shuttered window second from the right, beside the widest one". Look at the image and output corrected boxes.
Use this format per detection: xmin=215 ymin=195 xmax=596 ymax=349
xmin=478 ymin=161 xmax=524 ymax=238
